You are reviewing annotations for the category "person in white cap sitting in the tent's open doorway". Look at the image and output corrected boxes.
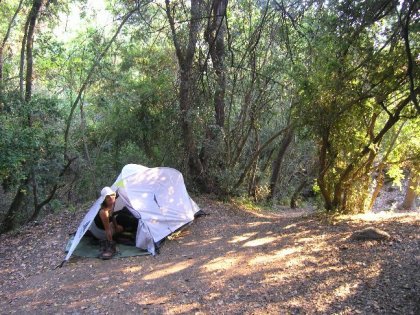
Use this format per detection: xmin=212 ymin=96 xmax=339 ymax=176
xmin=89 ymin=187 xmax=124 ymax=259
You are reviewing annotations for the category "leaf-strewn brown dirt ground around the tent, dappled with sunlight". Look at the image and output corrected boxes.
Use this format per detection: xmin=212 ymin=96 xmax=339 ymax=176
xmin=0 ymin=196 xmax=420 ymax=314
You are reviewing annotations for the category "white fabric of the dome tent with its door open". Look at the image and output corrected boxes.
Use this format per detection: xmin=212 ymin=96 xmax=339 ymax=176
xmin=63 ymin=164 xmax=200 ymax=263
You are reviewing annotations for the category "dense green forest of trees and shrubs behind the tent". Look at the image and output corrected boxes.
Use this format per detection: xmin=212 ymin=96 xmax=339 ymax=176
xmin=0 ymin=0 xmax=420 ymax=232
